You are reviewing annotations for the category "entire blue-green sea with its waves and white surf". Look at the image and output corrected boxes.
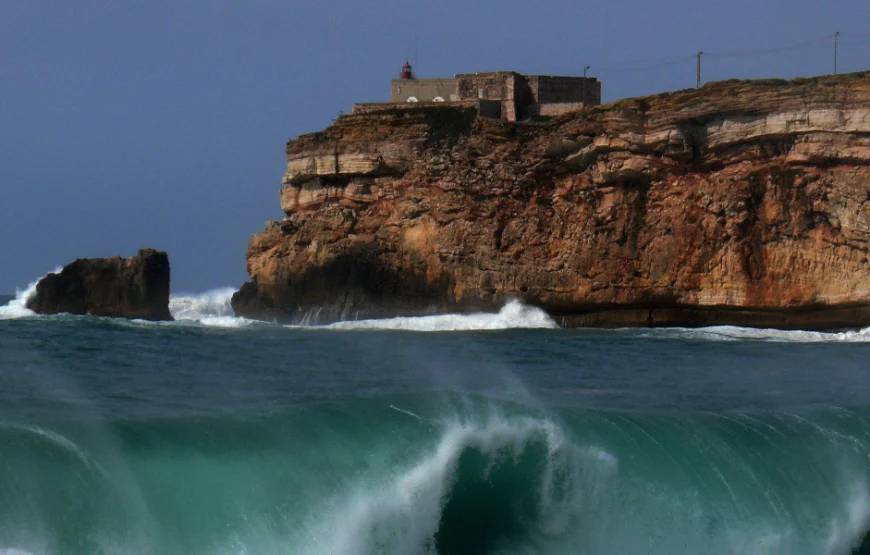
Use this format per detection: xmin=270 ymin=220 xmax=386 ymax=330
xmin=0 ymin=278 xmax=870 ymax=555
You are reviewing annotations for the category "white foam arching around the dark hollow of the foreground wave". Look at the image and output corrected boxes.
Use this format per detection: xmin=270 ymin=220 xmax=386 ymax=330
xmin=292 ymin=415 xmax=600 ymax=555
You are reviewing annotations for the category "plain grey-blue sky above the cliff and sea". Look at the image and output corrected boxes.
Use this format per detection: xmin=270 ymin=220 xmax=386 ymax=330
xmin=0 ymin=0 xmax=870 ymax=293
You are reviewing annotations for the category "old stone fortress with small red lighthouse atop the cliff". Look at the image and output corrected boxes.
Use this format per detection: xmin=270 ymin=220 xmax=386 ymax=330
xmin=353 ymin=62 xmax=601 ymax=121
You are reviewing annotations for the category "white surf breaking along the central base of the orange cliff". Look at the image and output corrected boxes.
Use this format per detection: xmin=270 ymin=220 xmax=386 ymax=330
xmin=324 ymin=300 xmax=559 ymax=331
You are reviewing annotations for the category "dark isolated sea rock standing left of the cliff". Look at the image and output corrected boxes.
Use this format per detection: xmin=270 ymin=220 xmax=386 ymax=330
xmin=27 ymin=249 xmax=172 ymax=320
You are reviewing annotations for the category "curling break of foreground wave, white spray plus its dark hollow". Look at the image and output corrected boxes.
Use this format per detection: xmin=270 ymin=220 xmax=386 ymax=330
xmin=302 ymin=417 xmax=618 ymax=555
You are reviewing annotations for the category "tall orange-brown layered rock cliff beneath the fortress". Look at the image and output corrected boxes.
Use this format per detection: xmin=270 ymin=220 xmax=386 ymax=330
xmin=233 ymin=74 xmax=870 ymax=329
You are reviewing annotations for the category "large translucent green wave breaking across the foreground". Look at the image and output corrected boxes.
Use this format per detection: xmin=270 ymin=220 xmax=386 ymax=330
xmin=0 ymin=395 xmax=870 ymax=555
